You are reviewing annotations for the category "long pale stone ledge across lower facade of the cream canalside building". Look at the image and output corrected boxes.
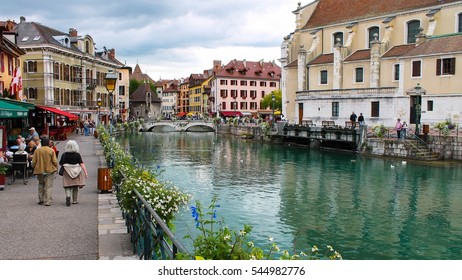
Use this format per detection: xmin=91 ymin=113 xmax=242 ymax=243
xmin=296 ymin=87 xmax=398 ymax=101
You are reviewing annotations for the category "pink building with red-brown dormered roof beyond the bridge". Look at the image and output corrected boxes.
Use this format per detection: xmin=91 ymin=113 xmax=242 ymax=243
xmin=210 ymin=59 xmax=281 ymax=117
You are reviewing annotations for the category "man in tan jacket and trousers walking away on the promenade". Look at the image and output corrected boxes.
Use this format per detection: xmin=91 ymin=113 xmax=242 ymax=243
xmin=32 ymin=137 xmax=58 ymax=206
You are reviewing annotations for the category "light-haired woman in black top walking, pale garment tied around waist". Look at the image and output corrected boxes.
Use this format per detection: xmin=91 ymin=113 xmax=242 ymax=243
xmin=59 ymin=140 xmax=88 ymax=206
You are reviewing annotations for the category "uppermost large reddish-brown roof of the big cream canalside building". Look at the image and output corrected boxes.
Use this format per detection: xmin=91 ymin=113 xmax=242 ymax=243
xmin=302 ymin=0 xmax=458 ymax=29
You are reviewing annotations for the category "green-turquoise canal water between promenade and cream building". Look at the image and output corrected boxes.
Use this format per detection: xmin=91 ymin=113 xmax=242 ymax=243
xmin=117 ymin=132 xmax=462 ymax=260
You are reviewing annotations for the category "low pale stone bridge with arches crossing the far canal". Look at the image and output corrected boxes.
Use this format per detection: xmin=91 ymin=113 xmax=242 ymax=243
xmin=141 ymin=120 xmax=215 ymax=132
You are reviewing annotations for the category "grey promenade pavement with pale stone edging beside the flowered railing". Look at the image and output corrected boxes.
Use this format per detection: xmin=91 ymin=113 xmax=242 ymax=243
xmin=0 ymin=134 xmax=137 ymax=260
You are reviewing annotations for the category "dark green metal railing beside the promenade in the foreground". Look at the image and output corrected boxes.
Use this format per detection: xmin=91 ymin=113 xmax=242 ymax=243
xmin=115 ymin=174 xmax=189 ymax=260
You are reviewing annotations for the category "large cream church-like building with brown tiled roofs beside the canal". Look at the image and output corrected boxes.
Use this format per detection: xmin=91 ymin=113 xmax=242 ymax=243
xmin=280 ymin=0 xmax=462 ymax=127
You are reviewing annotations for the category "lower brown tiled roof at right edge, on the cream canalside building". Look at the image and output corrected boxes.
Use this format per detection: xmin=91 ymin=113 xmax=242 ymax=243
xmin=406 ymin=33 xmax=462 ymax=56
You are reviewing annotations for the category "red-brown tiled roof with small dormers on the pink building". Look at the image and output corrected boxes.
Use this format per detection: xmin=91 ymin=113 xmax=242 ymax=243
xmin=216 ymin=59 xmax=281 ymax=80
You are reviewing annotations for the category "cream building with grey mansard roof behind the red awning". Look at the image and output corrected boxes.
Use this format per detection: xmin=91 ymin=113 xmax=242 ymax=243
xmin=16 ymin=17 xmax=125 ymax=121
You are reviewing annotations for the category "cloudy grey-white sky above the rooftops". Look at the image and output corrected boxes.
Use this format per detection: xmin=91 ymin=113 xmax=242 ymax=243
xmin=0 ymin=0 xmax=306 ymax=80
